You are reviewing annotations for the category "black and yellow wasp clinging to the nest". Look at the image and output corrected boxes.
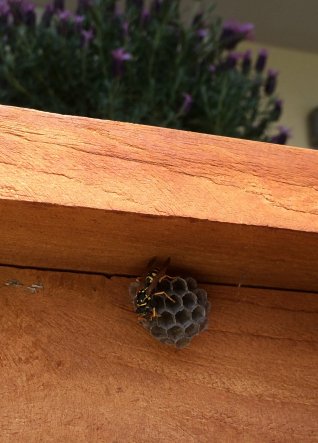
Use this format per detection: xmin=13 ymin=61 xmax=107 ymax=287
xmin=135 ymin=257 xmax=175 ymax=320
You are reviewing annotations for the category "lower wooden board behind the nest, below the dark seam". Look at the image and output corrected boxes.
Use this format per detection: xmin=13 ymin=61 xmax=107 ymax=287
xmin=0 ymin=268 xmax=318 ymax=443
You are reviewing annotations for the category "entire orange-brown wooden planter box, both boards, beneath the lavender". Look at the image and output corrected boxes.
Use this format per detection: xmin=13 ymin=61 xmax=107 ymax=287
xmin=0 ymin=106 xmax=318 ymax=443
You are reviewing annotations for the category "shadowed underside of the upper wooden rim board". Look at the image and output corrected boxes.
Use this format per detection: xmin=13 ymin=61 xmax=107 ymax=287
xmin=0 ymin=200 xmax=318 ymax=291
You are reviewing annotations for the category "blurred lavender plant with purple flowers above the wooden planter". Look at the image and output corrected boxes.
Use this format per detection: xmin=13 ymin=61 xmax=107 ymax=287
xmin=0 ymin=0 xmax=289 ymax=144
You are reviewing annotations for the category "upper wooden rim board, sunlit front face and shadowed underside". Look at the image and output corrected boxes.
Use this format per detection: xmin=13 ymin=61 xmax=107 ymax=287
xmin=0 ymin=106 xmax=318 ymax=291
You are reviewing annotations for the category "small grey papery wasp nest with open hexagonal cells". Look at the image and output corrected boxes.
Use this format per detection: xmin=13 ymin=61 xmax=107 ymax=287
xmin=131 ymin=277 xmax=210 ymax=348
